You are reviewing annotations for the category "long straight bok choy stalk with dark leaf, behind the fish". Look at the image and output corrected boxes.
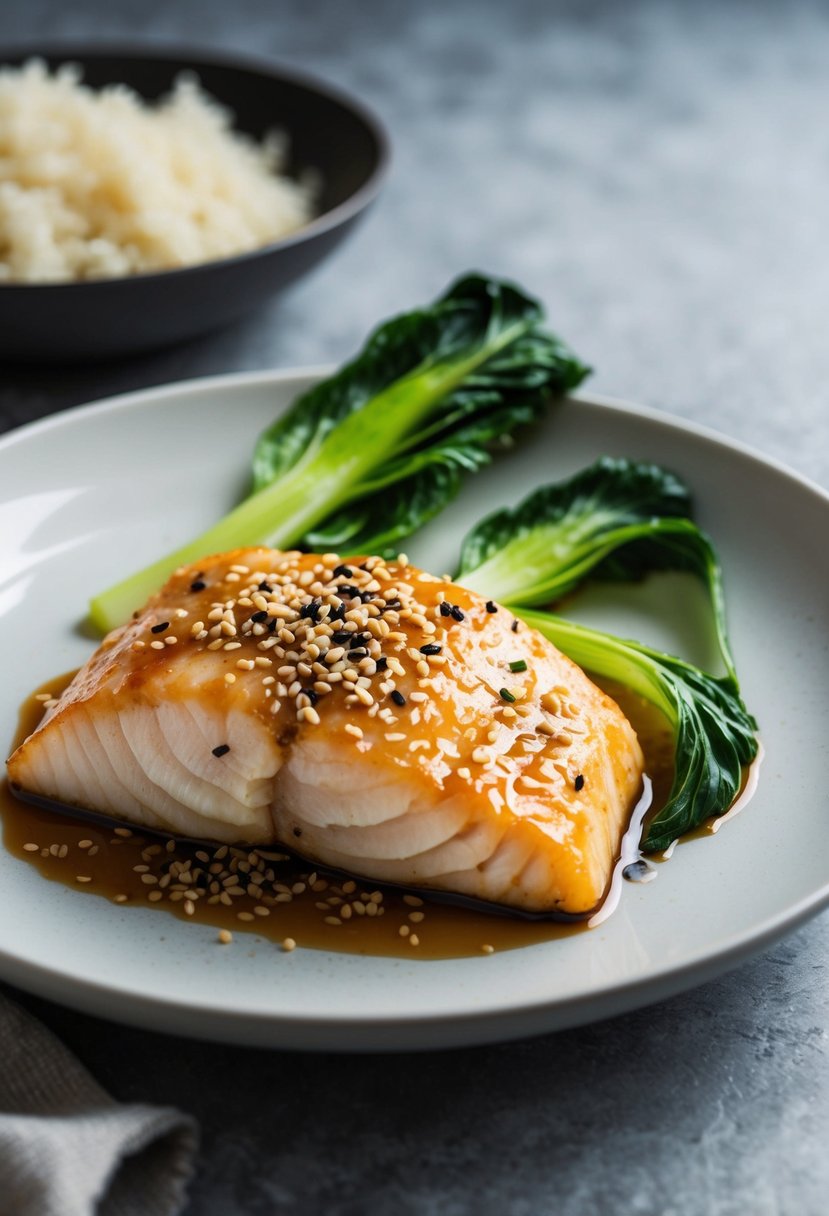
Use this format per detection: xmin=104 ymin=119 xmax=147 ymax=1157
xmin=90 ymin=275 xmax=588 ymax=630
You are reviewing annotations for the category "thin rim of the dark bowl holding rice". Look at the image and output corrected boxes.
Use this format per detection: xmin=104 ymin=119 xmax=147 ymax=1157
xmin=0 ymin=39 xmax=391 ymax=293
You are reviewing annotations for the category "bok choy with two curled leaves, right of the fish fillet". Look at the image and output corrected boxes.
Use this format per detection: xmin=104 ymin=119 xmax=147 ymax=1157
xmin=457 ymin=458 xmax=757 ymax=851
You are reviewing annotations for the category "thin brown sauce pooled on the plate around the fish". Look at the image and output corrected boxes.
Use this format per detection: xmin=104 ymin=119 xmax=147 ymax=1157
xmin=0 ymin=672 xmax=673 ymax=958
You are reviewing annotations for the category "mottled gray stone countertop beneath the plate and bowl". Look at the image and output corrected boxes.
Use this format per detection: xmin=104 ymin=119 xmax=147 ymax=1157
xmin=0 ymin=0 xmax=829 ymax=1216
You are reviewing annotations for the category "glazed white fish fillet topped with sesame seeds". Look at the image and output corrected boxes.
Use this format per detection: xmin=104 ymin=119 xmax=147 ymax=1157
xmin=3 ymin=548 xmax=643 ymax=914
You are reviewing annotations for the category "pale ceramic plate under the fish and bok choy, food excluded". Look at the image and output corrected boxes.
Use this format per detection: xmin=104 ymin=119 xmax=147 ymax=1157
xmin=0 ymin=372 xmax=829 ymax=1049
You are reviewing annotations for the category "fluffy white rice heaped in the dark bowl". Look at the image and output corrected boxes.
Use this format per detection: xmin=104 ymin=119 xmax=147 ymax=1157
xmin=0 ymin=61 xmax=312 ymax=283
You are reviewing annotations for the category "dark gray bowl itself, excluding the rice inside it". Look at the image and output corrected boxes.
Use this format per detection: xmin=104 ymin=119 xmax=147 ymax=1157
xmin=0 ymin=45 xmax=388 ymax=362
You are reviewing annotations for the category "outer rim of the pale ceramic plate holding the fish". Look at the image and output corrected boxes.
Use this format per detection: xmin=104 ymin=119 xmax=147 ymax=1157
xmin=0 ymin=365 xmax=829 ymax=1051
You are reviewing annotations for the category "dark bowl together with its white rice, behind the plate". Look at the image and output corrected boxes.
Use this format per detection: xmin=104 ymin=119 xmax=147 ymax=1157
xmin=0 ymin=46 xmax=388 ymax=361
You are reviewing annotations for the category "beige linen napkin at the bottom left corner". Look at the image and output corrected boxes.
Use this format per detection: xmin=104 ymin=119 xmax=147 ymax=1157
xmin=0 ymin=993 xmax=198 ymax=1216
